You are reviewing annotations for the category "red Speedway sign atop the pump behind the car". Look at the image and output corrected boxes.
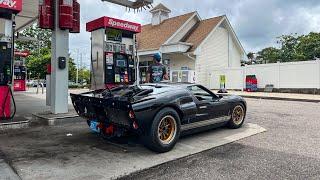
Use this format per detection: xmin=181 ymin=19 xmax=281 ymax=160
xmin=87 ymin=16 xmax=141 ymax=33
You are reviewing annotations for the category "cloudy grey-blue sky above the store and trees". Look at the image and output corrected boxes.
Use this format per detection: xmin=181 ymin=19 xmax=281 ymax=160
xmin=70 ymin=0 xmax=320 ymax=66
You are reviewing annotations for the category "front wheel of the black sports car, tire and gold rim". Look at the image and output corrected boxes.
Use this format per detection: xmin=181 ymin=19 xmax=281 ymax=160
xmin=227 ymin=104 xmax=246 ymax=129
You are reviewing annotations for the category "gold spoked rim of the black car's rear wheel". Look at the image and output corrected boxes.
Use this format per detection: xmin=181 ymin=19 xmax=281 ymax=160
xmin=158 ymin=115 xmax=177 ymax=144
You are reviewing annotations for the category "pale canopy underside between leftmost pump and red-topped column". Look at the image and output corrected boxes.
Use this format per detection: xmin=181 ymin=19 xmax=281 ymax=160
xmin=16 ymin=0 xmax=39 ymax=31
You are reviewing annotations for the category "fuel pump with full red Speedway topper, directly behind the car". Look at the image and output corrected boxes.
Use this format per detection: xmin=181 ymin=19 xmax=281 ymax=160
xmin=87 ymin=16 xmax=141 ymax=89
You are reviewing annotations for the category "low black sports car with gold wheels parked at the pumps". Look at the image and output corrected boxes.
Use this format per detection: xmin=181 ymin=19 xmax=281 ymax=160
xmin=71 ymin=83 xmax=246 ymax=152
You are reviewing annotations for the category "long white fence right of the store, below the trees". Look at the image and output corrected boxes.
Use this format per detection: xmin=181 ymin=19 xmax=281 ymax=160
xmin=209 ymin=60 xmax=320 ymax=89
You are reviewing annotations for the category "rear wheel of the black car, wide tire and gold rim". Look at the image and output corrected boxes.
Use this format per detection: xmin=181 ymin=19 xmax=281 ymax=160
xmin=143 ymin=108 xmax=181 ymax=153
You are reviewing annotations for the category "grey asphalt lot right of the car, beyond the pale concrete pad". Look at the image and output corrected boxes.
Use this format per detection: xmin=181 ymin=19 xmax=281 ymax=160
xmin=123 ymin=99 xmax=320 ymax=180
